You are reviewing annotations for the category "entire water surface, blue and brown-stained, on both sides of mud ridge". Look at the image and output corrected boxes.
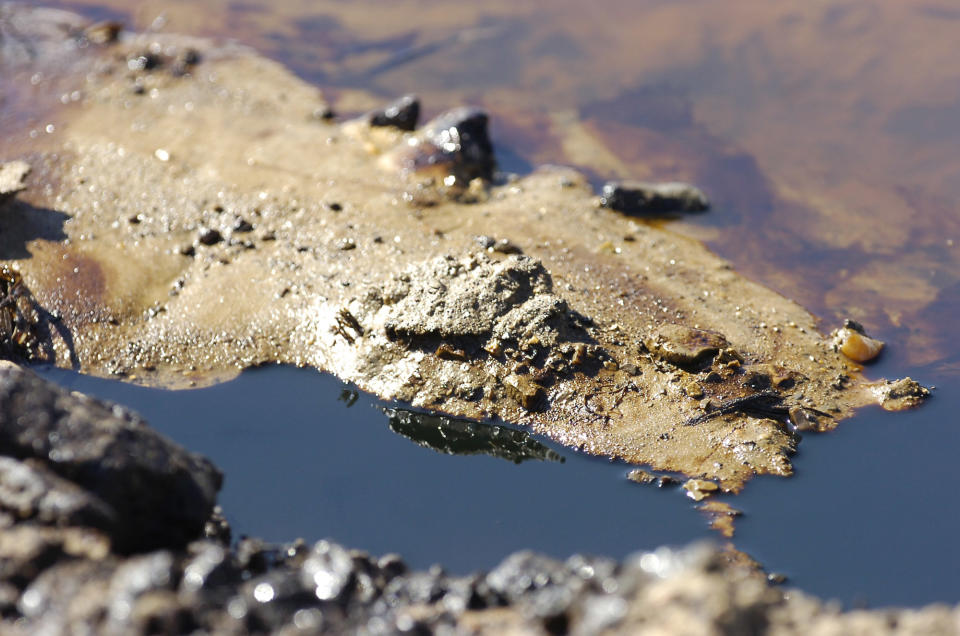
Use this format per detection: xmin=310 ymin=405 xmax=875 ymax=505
xmin=22 ymin=0 xmax=960 ymax=605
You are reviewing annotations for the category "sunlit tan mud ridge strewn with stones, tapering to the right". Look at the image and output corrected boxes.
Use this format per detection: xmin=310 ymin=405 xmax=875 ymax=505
xmin=0 ymin=8 xmax=924 ymax=492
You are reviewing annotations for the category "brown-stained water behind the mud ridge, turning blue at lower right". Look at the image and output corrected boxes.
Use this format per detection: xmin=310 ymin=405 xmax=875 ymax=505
xmin=11 ymin=0 xmax=960 ymax=604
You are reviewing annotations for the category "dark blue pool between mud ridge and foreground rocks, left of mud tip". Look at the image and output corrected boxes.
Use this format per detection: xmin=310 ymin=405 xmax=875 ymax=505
xmin=33 ymin=367 xmax=710 ymax=573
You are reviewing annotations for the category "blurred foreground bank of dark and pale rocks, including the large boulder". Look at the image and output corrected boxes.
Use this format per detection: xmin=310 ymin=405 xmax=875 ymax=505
xmin=0 ymin=363 xmax=960 ymax=635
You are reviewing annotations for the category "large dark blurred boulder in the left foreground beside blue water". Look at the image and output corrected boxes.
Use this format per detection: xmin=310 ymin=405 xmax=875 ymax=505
xmin=0 ymin=363 xmax=222 ymax=551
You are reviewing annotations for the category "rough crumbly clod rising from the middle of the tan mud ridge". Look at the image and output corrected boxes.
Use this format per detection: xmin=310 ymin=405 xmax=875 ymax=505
xmin=333 ymin=253 xmax=603 ymax=412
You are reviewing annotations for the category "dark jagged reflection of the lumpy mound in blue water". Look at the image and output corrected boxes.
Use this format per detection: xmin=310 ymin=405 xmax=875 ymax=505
xmin=383 ymin=409 xmax=563 ymax=464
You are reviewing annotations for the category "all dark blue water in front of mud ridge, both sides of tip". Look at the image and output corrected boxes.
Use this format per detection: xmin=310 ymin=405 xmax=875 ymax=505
xmin=41 ymin=360 xmax=960 ymax=606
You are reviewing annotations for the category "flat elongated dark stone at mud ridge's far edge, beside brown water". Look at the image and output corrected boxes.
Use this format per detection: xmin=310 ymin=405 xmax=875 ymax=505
xmin=600 ymin=181 xmax=710 ymax=215
